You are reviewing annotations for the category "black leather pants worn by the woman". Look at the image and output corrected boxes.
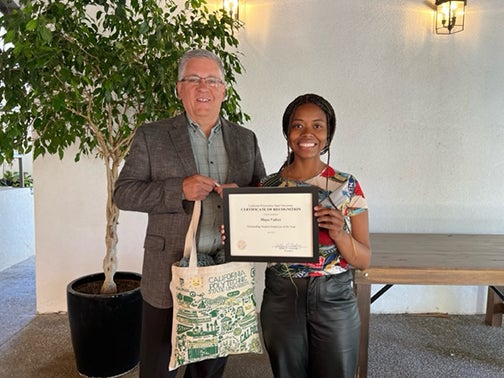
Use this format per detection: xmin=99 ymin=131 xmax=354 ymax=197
xmin=261 ymin=269 xmax=360 ymax=378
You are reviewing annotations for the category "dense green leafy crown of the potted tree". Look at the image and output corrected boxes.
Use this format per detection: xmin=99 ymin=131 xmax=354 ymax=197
xmin=0 ymin=0 xmax=250 ymax=280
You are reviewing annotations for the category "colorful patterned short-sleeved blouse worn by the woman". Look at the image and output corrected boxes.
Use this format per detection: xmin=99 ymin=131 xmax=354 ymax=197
xmin=261 ymin=166 xmax=368 ymax=278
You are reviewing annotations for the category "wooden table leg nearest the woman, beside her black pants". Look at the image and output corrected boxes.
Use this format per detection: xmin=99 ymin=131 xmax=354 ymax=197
xmin=355 ymin=284 xmax=371 ymax=378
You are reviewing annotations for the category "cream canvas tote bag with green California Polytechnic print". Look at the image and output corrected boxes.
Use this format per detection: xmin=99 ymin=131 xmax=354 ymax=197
xmin=169 ymin=201 xmax=262 ymax=370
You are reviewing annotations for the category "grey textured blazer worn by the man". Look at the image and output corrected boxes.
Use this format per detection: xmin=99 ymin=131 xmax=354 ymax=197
xmin=114 ymin=114 xmax=266 ymax=308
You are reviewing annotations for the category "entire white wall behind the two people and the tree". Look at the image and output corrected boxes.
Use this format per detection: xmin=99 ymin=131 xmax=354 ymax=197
xmin=34 ymin=0 xmax=504 ymax=314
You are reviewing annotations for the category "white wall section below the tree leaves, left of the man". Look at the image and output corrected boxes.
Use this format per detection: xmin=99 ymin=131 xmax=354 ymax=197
xmin=34 ymin=152 xmax=146 ymax=313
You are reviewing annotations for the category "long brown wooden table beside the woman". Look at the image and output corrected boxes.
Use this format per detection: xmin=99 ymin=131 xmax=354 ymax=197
xmin=355 ymin=234 xmax=504 ymax=377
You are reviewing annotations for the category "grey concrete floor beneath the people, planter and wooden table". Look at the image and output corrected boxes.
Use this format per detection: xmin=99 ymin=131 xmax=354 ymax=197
xmin=0 ymin=258 xmax=504 ymax=378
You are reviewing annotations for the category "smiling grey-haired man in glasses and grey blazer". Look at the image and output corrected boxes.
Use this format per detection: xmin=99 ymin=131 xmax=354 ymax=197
xmin=114 ymin=50 xmax=265 ymax=378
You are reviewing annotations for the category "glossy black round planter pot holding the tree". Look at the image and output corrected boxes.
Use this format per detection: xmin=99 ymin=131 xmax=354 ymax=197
xmin=67 ymin=272 xmax=142 ymax=377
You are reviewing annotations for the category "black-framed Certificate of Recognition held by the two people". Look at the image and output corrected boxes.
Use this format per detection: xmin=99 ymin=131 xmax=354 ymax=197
xmin=223 ymin=186 xmax=319 ymax=262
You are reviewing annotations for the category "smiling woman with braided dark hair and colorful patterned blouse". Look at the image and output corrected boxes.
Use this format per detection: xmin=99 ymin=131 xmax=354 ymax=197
xmin=261 ymin=94 xmax=371 ymax=378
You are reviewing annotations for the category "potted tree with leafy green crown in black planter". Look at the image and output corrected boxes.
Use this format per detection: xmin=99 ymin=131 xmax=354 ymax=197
xmin=0 ymin=0 xmax=249 ymax=376
